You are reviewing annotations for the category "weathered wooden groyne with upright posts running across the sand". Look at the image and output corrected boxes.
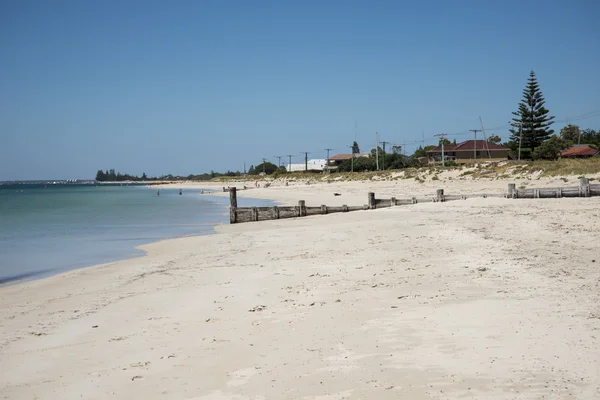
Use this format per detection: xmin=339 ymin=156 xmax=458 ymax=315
xmin=228 ymin=178 xmax=600 ymax=224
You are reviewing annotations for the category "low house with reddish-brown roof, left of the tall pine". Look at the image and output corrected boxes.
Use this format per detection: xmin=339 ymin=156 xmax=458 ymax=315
xmin=427 ymin=140 xmax=510 ymax=163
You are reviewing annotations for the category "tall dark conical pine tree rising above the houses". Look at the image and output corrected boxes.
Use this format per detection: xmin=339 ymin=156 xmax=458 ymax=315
xmin=510 ymin=71 xmax=554 ymax=152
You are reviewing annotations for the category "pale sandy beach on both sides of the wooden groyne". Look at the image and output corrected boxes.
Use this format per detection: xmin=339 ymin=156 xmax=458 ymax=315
xmin=0 ymin=177 xmax=600 ymax=400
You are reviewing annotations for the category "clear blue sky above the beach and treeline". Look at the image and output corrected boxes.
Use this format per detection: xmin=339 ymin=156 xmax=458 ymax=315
xmin=0 ymin=0 xmax=600 ymax=180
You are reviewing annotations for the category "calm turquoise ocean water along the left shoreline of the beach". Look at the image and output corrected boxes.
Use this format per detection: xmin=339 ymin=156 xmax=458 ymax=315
xmin=0 ymin=184 xmax=266 ymax=283
